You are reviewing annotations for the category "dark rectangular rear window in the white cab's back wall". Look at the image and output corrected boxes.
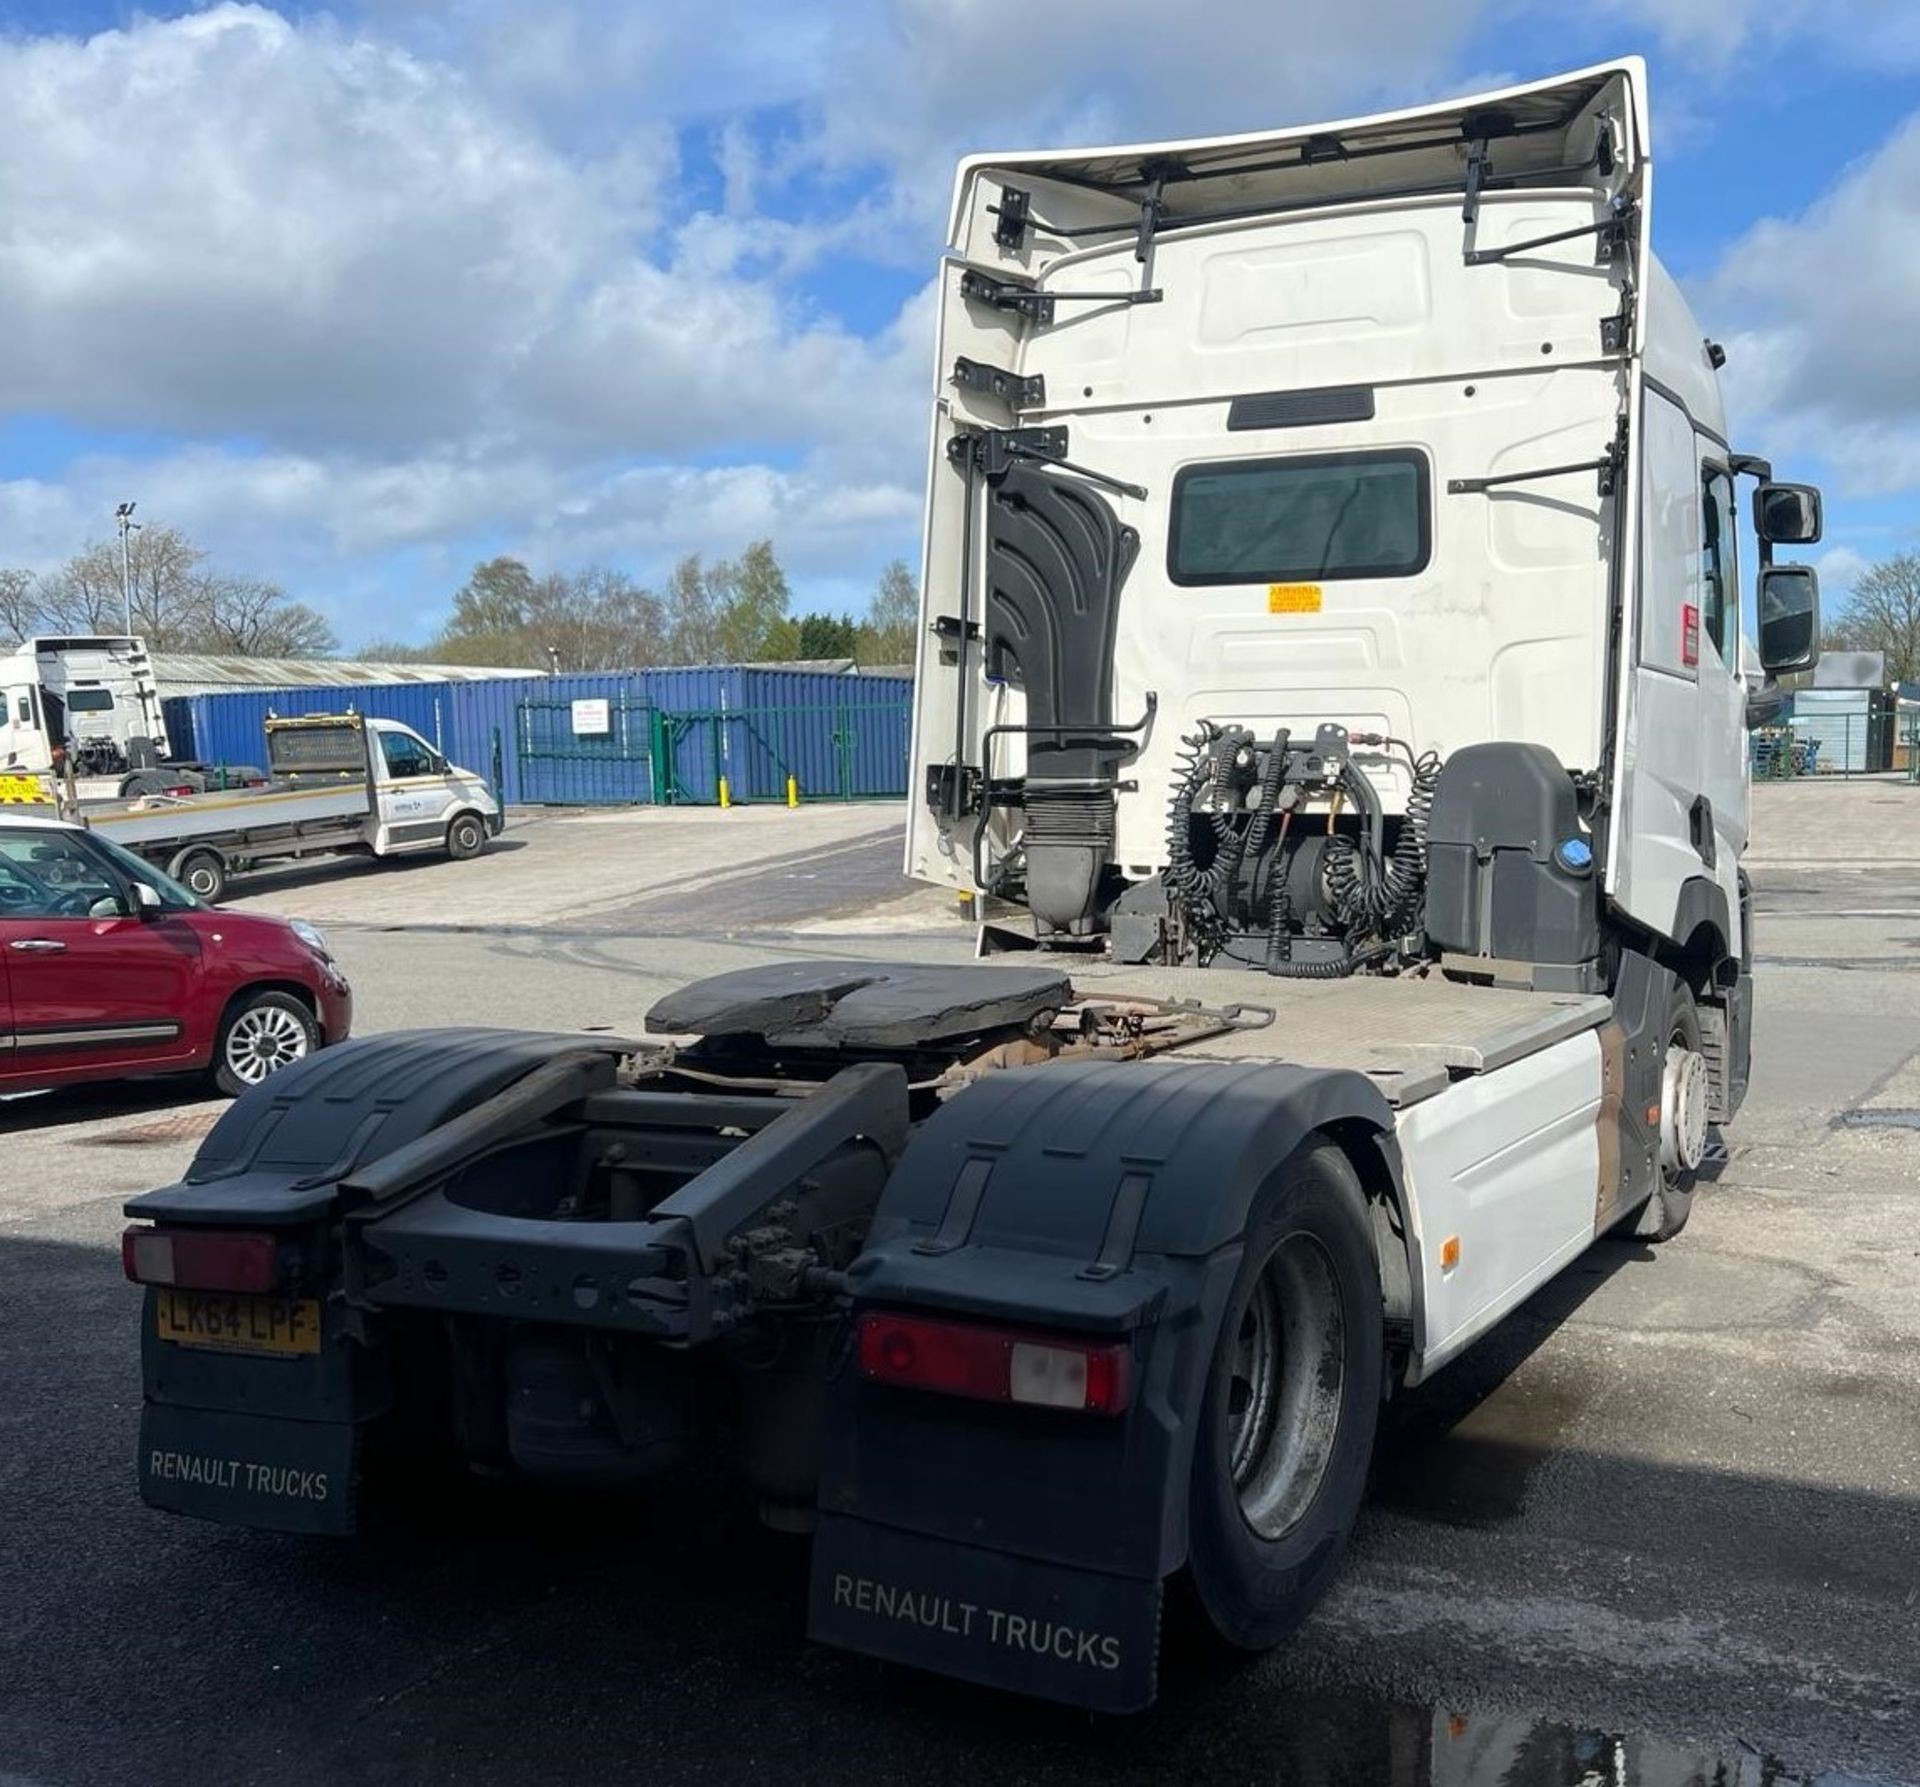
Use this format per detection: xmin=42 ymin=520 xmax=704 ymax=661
xmin=1167 ymin=451 xmax=1432 ymax=585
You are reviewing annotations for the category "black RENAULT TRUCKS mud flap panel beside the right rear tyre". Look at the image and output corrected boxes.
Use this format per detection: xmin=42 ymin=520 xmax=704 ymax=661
xmin=806 ymin=1513 xmax=1162 ymax=1712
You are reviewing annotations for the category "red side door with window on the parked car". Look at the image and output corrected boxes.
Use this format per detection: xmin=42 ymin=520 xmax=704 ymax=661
xmin=0 ymin=827 xmax=207 ymax=1084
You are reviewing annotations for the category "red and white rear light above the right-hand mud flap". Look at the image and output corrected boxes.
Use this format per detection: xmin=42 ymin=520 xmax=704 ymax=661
xmin=858 ymin=1313 xmax=1133 ymax=1415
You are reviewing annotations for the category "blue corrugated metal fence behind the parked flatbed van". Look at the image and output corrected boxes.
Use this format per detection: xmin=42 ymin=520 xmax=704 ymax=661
xmin=167 ymin=664 xmax=912 ymax=806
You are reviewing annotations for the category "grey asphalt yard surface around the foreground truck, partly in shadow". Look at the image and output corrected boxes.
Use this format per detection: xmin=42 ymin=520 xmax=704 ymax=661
xmin=0 ymin=785 xmax=1920 ymax=1787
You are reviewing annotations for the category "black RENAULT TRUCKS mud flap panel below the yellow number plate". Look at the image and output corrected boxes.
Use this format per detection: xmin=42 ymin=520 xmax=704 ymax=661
xmin=140 ymin=1403 xmax=359 ymax=1534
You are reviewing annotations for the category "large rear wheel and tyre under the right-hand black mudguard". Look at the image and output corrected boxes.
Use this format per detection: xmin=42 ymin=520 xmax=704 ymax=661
xmin=1188 ymin=1142 xmax=1384 ymax=1651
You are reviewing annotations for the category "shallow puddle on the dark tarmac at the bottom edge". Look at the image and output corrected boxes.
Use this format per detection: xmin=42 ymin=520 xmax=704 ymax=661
xmin=1190 ymin=1695 xmax=1895 ymax=1787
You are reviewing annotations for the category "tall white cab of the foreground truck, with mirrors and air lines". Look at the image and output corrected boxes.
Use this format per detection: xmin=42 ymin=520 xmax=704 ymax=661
xmin=906 ymin=58 xmax=1820 ymax=1059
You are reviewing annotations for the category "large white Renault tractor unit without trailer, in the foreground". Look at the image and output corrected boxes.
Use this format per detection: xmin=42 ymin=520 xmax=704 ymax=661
xmin=125 ymin=60 xmax=1820 ymax=1710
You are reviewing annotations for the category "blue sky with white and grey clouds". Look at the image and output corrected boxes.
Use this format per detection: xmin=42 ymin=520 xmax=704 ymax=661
xmin=0 ymin=0 xmax=1920 ymax=647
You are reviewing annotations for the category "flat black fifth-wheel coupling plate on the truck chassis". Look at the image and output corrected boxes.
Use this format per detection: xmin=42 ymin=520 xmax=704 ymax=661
xmin=647 ymin=962 xmax=1073 ymax=1048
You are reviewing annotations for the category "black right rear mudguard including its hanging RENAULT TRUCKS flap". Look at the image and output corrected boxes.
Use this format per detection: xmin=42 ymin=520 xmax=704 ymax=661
xmin=810 ymin=1061 xmax=1398 ymax=1710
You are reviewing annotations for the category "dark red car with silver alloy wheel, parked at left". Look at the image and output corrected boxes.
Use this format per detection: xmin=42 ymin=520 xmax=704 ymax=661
xmin=0 ymin=810 xmax=353 ymax=1094
